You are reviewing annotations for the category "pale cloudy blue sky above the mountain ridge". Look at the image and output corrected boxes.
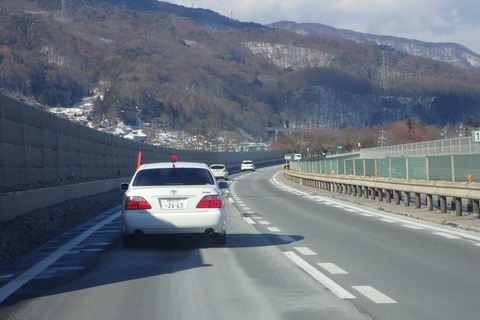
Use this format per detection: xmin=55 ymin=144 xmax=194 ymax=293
xmin=168 ymin=0 xmax=480 ymax=53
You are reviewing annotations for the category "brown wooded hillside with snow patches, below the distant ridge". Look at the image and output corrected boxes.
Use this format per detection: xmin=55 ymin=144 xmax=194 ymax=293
xmin=0 ymin=0 xmax=480 ymax=141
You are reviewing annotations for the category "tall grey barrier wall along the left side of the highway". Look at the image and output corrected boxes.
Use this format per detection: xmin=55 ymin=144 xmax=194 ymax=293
xmin=0 ymin=94 xmax=284 ymax=222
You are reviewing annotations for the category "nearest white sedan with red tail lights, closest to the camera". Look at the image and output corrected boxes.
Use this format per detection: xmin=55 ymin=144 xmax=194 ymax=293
xmin=121 ymin=162 xmax=228 ymax=247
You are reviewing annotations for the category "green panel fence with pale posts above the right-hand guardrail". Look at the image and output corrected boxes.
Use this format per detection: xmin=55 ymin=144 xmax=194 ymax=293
xmin=290 ymin=154 xmax=480 ymax=182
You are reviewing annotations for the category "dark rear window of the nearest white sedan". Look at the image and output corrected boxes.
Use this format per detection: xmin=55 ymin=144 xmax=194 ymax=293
xmin=132 ymin=168 xmax=215 ymax=186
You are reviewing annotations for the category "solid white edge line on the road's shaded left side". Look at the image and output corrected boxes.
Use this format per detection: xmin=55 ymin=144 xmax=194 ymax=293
xmin=0 ymin=208 xmax=120 ymax=303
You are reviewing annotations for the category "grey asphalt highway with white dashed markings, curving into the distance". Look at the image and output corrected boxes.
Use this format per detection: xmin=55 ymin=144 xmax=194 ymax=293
xmin=0 ymin=168 xmax=480 ymax=320
